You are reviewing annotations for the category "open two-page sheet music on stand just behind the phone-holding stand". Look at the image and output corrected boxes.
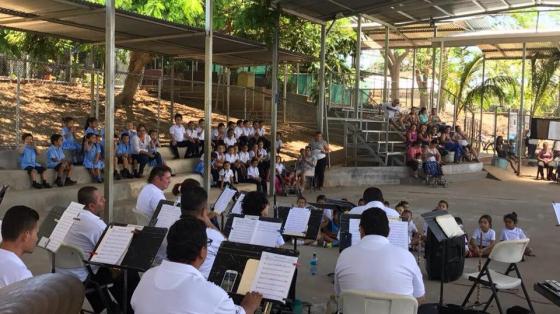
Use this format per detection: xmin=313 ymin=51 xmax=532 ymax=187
xmin=224 ymin=215 xmax=282 ymax=247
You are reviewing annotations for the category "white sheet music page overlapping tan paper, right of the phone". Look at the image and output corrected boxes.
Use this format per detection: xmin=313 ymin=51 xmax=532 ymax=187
xmin=251 ymin=252 xmax=298 ymax=303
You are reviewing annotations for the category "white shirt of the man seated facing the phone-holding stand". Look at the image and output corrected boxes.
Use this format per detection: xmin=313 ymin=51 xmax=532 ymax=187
xmin=130 ymin=261 xmax=245 ymax=314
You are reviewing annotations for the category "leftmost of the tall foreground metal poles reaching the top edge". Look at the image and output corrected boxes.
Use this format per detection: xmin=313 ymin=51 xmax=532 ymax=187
xmin=104 ymin=0 xmax=115 ymax=222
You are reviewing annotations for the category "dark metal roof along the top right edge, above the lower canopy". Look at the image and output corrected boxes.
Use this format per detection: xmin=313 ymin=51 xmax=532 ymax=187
xmin=273 ymin=0 xmax=560 ymax=26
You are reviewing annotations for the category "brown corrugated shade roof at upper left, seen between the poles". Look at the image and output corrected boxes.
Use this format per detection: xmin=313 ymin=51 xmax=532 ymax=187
xmin=0 ymin=0 xmax=311 ymax=66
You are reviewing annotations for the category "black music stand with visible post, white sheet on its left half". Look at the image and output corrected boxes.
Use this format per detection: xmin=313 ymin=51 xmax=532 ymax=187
xmin=84 ymin=224 xmax=167 ymax=313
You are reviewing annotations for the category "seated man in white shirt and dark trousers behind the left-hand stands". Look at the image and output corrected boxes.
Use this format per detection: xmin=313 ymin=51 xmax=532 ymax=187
xmin=56 ymin=186 xmax=140 ymax=313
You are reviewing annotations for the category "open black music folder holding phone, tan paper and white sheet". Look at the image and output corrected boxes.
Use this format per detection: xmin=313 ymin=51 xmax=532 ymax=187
xmin=208 ymin=241 xmax=299 ymax=304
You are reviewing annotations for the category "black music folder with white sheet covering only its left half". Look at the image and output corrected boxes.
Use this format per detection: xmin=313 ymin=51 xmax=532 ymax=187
xmin=87 ymin=224 xmax=167 ymax=272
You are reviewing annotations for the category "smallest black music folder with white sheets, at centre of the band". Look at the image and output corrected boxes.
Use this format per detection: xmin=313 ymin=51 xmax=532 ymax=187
xmin=277 ymin=206 xmax=323 ymax=240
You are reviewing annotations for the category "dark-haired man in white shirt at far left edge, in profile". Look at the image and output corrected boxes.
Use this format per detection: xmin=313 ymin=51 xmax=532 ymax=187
xmin=0 ymin=206 xmax=39 ymax=288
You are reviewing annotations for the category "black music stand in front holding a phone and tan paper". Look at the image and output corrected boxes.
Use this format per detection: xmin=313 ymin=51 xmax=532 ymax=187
xmin=208 ymin=241 xmax=299 ymax=306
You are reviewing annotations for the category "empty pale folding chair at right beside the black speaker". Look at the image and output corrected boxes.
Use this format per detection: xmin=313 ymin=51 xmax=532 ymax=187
xmin=461 ymin=239 xmax=535 ymax=314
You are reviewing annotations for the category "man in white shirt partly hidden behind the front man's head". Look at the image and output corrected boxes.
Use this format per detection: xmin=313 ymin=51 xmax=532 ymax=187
xmin=179 ymin=186 xmax=225 ymax=278
